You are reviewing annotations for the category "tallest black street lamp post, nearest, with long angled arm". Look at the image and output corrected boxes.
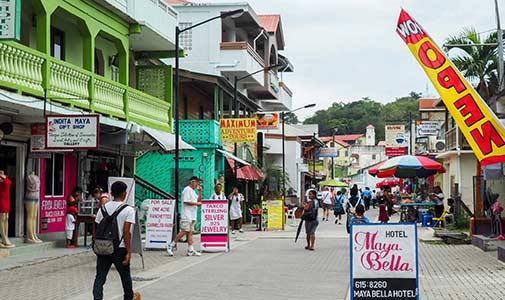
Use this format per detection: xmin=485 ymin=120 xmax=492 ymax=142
xmin=173 ymin=9 xmax=244 ymax=234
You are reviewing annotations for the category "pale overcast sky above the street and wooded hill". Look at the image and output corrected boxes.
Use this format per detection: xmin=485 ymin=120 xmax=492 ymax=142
xmin=193 ymin=0 xmax=498 ymax=120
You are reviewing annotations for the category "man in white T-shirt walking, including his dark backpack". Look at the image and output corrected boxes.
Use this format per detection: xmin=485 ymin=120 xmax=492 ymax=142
xmin=93 ymin=181 xmax=135 ymax=300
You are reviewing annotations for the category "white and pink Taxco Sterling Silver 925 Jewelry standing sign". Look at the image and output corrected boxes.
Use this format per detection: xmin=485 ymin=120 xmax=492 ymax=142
xmin=200 ymin=200 xmax=229 ymax=252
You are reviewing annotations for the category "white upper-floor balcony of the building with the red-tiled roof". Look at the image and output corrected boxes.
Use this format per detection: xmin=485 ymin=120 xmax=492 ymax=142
xmin=219 ymin=42 xmax=265 ymax=88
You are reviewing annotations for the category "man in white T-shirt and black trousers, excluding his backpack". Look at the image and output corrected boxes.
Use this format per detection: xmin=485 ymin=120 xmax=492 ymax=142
xmin=93 ymin=181 xmax=136 ymax=300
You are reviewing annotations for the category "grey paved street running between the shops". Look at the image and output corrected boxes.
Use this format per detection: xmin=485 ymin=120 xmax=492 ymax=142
xmin=0 ymin=207 xmax=505 ymax=300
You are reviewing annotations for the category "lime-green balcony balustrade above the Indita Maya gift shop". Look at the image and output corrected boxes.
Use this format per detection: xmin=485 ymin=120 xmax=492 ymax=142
xmin=0 ymin=42 xmax=172 ymax=131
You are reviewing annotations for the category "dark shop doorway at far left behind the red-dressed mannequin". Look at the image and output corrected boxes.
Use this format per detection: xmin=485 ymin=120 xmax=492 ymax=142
xmin=0 ymin=145 xmax=17 ymax=237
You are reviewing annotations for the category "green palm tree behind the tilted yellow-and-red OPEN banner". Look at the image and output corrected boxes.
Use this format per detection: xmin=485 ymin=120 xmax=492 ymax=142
xmin=444 ymin=27 xmax=499 ymax=101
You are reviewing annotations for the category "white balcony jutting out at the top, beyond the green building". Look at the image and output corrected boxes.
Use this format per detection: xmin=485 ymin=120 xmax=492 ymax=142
xmin=97 ymin=0 xmax=177 ymax=51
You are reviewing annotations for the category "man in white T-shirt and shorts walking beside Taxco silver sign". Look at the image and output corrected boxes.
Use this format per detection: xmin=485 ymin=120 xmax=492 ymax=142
xmin=167 ymin=176 xmax=202 ymax=256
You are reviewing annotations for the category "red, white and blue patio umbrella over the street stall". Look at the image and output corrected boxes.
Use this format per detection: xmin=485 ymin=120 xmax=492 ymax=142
xmin=376 ymin=155 xmax=445 ymax=178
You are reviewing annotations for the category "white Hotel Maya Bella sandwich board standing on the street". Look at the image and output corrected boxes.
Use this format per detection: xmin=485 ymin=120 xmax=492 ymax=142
xmin=350 ymin=224 xmax=419 ymax=300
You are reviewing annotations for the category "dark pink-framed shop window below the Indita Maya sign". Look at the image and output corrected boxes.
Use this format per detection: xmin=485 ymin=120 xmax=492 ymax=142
xmin=44 ymin=153 xmax=65 ymax=196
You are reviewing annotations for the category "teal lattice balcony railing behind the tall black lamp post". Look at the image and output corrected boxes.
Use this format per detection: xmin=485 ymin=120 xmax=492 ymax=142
xmin=179 ymin=120 xmax=221 ymax=147
